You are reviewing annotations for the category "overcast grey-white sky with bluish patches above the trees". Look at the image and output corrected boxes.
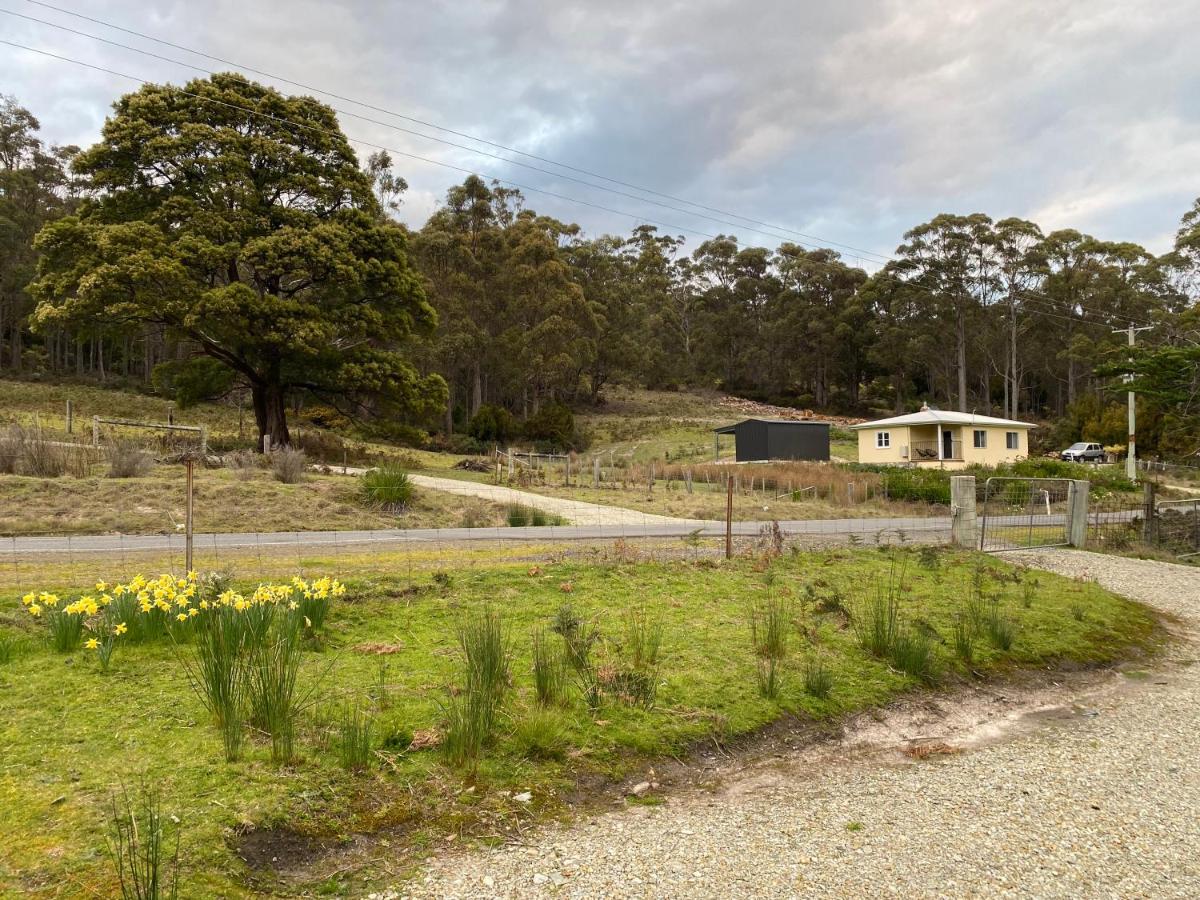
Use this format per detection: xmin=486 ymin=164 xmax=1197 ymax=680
xmin=0 ymin=0 xmax=1200 ymax=268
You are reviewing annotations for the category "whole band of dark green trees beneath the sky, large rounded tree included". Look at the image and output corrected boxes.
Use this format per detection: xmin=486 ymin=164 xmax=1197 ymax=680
xmin=0 ymin=74 xmax=1200 ymax=454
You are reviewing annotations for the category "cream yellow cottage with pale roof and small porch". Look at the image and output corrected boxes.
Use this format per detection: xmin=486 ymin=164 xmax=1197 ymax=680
xmin=851 ymin=407 xmax=1037 ymax=469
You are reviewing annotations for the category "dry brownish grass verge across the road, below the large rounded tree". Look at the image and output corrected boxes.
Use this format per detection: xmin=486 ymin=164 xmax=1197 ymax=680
xmin=0 ymin=466 xmax=505 ymax=536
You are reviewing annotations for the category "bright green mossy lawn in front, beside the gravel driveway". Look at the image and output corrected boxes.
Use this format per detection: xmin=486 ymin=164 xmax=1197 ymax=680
xmin=0 ymin=548 xmax=1158 ymax=896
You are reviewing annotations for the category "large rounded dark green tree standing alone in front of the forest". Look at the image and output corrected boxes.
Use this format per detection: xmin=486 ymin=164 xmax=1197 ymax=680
xmin=31 ymin=74 xmax=445 ymax=444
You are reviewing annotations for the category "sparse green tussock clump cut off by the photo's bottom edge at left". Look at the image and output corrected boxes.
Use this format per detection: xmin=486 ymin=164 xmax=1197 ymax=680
xmin=107 ymin=784 xmax=180 ymax=900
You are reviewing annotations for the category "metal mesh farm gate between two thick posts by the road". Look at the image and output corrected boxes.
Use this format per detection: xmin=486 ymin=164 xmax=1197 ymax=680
xmin=979 ymin=478 xmax=1075 ymax=553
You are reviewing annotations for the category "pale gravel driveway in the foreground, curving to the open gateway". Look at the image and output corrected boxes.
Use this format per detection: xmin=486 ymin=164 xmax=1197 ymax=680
xmin=393 ymin=551 xmax=1200 ymax=898
